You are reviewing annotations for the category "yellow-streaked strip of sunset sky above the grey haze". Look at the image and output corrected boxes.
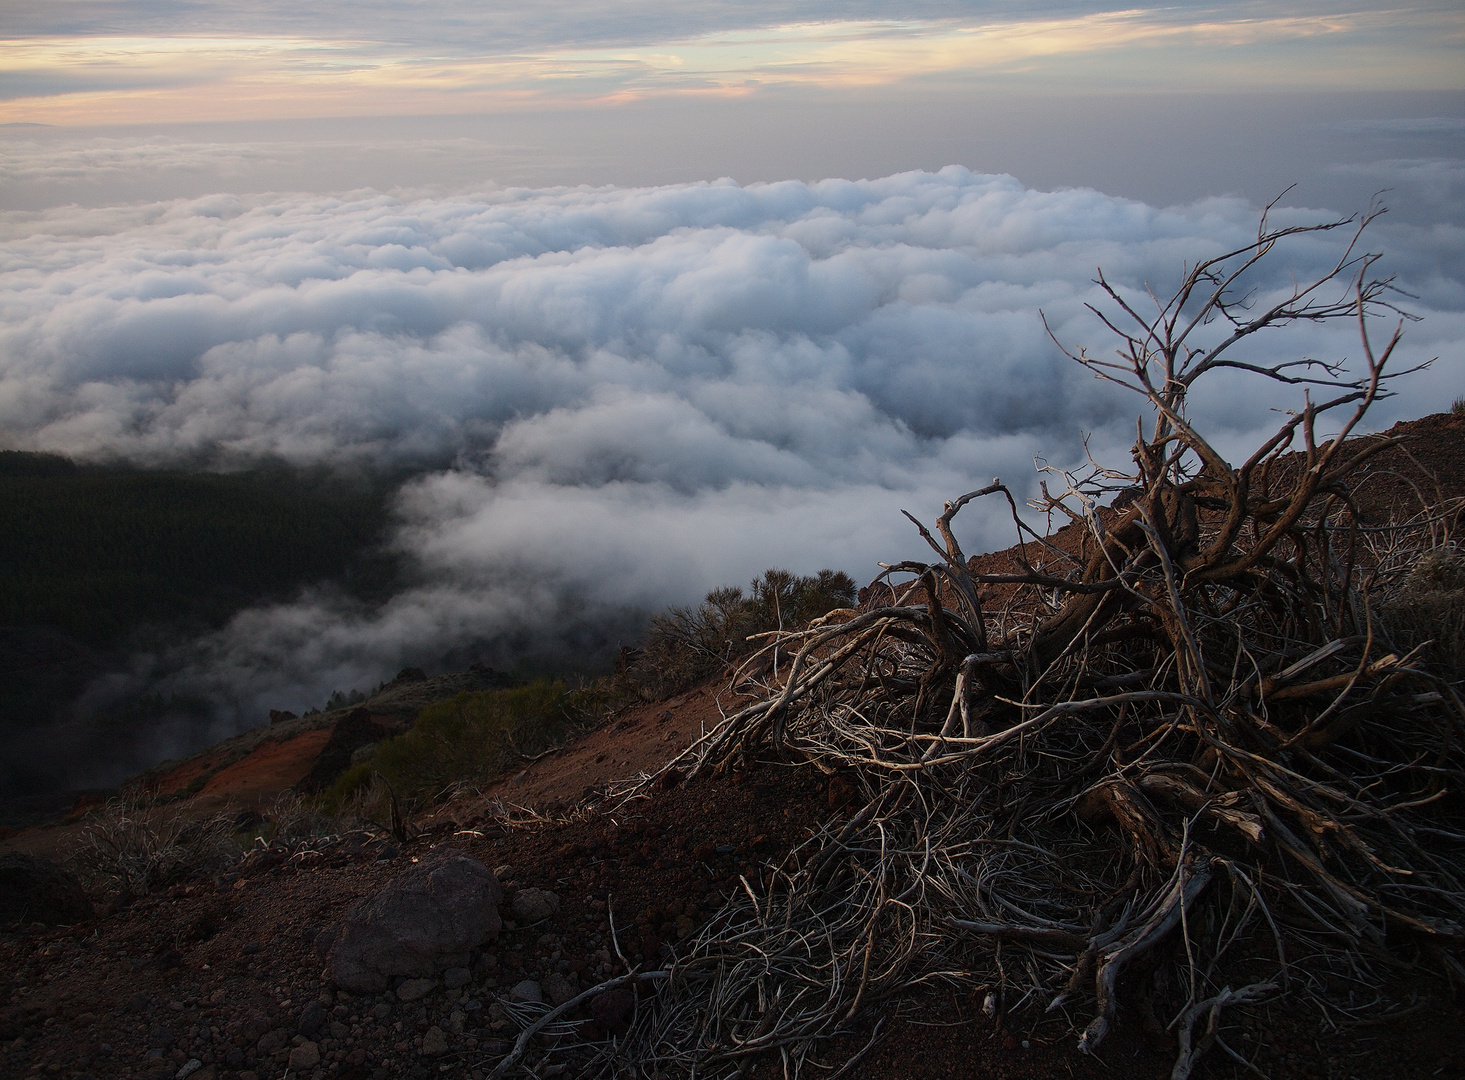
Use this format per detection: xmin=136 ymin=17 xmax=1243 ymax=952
xmin=0 ymin=0 xmax=1465 ymax=126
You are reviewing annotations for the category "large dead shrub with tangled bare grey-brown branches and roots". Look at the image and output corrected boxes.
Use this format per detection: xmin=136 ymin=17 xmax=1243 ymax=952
xmin=539 ymin=203 xmax=1465 ymax=1077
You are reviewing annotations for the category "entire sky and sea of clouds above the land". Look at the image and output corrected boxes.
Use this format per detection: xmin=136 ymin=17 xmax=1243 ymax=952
xmin=0 ymin=0 xmax=1465 ymax=781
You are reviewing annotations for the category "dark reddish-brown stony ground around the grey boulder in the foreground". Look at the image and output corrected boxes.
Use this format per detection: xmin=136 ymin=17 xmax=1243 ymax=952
xmin=0 ymin=765 xmax=1465 ymax=1080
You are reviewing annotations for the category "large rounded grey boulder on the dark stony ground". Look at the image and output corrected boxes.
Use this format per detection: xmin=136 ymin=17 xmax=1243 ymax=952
xmin=327 ymin=850 xmax=504 ymax=994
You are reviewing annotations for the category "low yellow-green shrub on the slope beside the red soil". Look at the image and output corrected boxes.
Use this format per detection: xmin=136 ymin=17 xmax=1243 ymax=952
xmin=324 ymin=680 xmax=571 ymax=807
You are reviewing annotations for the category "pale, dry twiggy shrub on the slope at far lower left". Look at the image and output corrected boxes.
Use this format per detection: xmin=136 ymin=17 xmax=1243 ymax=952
xmin=72 ymin=793 xmax=239 ymax=895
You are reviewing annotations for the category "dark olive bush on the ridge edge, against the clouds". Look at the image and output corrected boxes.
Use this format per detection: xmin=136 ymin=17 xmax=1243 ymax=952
xmin=623 ymin=569 xmax=856 ymax=699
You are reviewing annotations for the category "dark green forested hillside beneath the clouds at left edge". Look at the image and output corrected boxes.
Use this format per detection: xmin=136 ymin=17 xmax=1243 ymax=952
xmin=0 ymin=450 xmax=396 ymax=648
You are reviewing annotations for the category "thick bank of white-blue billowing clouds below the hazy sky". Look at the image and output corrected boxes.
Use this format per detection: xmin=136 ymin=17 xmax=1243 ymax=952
xmin=0 ymin=167 xmax=1465 ymax=785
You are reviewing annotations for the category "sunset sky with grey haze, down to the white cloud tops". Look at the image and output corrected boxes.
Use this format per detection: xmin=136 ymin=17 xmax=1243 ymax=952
xmin=0 ymin=0 xmax=1465 ymax=208
